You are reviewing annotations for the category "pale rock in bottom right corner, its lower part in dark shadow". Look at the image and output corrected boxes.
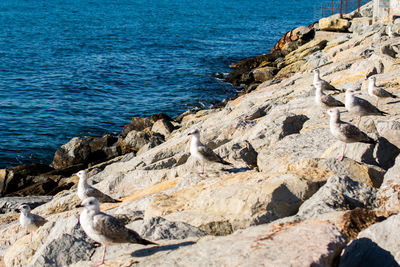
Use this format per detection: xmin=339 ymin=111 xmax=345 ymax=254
xmin=339 ymin=215 xmax=400 ymax=266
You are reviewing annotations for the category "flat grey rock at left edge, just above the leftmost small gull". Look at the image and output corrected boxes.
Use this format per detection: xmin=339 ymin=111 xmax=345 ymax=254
xmin=0 ymin=196 xmax=53 ymax=214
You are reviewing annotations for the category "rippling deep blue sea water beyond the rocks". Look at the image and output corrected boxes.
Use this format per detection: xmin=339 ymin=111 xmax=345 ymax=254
xmin=0 ymin=0 xmax=321 ymax=168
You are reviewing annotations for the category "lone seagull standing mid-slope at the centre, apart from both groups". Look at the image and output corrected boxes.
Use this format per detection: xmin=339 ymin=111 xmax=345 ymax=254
xmin=188 ymin=129 xmax=232 ymax=174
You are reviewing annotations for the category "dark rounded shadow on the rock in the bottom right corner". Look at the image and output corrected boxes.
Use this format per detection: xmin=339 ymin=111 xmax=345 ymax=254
xmin=339 ymin=238 xmax=399 ymax=267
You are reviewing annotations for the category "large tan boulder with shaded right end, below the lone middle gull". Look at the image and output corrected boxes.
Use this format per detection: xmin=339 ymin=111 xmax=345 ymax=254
xmin=145 ymin=171 xmax=321 ymax=235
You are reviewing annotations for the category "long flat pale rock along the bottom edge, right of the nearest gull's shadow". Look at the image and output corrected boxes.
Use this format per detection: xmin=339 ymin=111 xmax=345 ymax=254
xmin=134 ymin=221 xmax=347 ymax=266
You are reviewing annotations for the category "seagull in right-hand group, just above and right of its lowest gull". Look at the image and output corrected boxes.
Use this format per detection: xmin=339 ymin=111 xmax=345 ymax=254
xmin=344 ymin=89 xmax=388 ymax=127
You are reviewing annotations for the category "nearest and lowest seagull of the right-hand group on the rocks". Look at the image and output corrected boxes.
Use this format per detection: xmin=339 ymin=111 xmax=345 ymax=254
xmin=328 ymin=108 xmax=376 ymax=161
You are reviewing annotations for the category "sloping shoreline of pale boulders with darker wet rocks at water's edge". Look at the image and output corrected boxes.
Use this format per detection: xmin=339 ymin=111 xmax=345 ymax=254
xmin=0 ymin=2 xmax=400 ymax=266
